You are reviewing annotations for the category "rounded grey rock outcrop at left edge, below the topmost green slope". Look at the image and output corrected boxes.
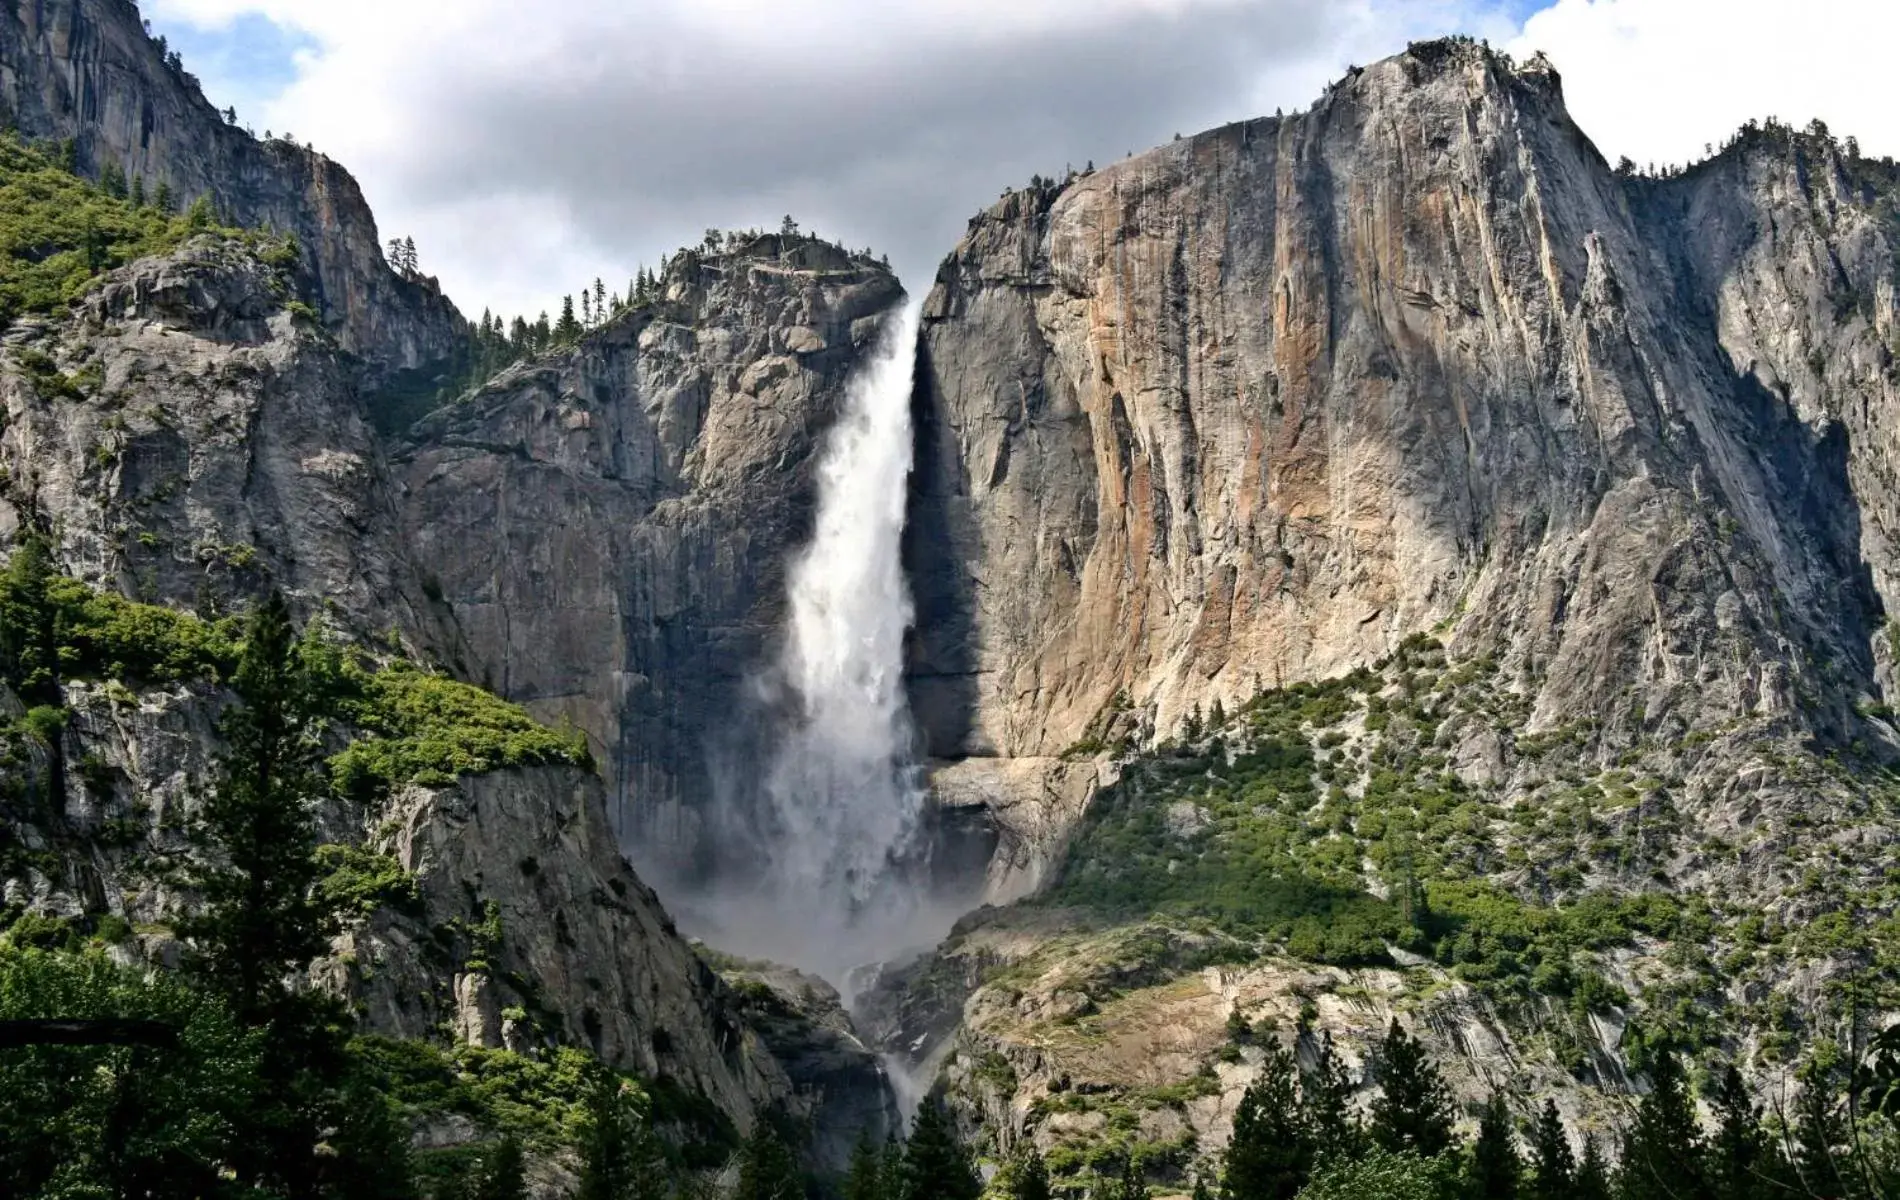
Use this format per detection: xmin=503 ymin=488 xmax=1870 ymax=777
xmin=0 ymin=235 xmax=454 ymax=653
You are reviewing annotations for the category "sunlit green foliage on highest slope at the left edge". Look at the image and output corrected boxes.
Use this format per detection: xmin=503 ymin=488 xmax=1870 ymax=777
xmin=0 ymin=133 xmax=236 ymax=328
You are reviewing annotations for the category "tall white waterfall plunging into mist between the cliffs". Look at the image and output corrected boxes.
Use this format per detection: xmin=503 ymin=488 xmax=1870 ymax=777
xmin=682 ymin=302 xmax=969 ymax=987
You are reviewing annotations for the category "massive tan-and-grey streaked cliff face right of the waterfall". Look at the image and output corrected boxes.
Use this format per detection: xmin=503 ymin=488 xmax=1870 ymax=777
xmin=912 ymin=42 xmax=1900 ymax=877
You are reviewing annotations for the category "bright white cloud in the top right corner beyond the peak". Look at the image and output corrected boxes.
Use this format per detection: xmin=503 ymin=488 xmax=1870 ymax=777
xmin=1509 ymin=0 xmax=1900 ymax=165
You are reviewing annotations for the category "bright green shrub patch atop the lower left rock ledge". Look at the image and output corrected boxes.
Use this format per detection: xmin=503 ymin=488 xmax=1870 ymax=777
xmin=331 ymin=663 xmax=593 ymax=796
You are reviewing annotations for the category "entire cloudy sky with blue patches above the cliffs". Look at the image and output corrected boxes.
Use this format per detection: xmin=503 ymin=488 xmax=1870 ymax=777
xmin=143 ymin=0 xmax=1900 ymax=315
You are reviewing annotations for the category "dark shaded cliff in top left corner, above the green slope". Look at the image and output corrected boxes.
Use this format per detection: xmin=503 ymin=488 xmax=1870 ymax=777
xmin=0 ymin=0 xmax=466 ymax=374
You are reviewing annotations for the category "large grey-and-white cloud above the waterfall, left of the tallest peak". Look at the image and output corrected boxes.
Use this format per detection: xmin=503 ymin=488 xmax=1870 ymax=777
xmin=146 ymin=0 xmax=1505 ymax=313
